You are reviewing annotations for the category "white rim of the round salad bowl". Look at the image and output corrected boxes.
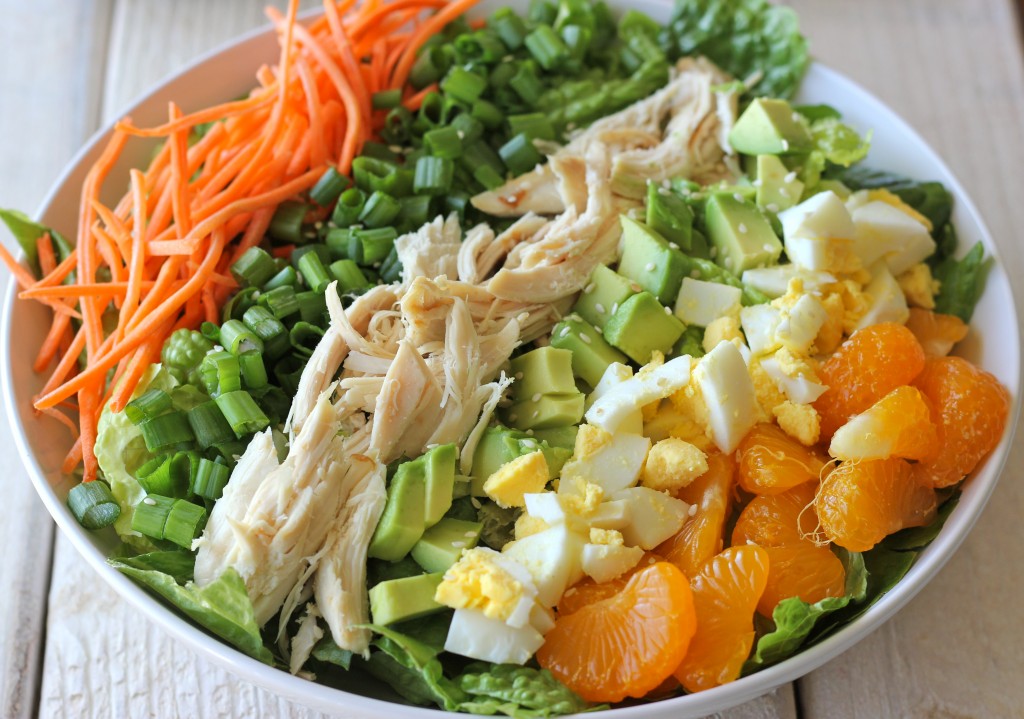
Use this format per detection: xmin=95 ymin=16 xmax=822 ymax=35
xmin=0 ymin=7 xmax=1024 ymax=719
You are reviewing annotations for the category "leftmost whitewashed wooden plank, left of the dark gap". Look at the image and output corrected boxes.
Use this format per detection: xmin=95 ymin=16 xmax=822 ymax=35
xmin=0 ymin=0 xmax=110 ymax=717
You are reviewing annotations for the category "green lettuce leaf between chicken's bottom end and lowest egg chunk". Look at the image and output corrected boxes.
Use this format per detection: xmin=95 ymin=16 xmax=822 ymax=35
xmin=367 ymin=625 xmax=467 ymax=712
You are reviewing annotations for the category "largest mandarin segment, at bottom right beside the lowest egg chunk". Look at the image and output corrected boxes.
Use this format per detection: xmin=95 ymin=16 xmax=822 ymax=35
xmin=537 ymin=561 xmax=696 ymax=702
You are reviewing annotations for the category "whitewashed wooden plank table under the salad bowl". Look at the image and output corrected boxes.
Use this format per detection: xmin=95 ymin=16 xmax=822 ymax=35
xmin=0 ymin=0 xmax=1024 ymax=719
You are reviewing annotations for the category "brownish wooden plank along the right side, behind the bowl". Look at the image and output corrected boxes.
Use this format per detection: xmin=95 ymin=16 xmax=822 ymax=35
xmin=791 ymin=0 xmax=1024 ymax=719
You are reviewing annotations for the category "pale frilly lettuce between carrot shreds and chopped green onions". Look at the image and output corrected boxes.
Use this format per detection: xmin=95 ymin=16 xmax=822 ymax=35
xmin=95 ymin=365 xmax=177 ymax=552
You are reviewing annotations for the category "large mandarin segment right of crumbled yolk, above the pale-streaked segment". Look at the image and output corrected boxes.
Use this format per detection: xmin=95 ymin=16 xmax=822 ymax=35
xmin=814 ymin=323 xmax=925 ymax=439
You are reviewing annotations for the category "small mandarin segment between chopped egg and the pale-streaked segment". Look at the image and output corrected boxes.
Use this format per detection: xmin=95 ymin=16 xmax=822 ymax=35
xmin=736 ymin=423 xmax=825 ymax=495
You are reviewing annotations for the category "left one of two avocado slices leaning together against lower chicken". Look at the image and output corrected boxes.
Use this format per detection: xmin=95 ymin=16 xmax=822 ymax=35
xmin=367 ymin=461 xmax=426 ymax=561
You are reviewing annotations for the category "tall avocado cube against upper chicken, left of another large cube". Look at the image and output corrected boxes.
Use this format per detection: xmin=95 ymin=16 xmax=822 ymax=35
xmin=618 ymin=215 xmax=685 ymax=304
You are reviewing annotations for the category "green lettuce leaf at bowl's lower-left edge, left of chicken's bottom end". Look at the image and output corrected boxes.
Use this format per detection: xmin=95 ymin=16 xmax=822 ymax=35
xmin=106 ymin=558 xmax=273 ymax=664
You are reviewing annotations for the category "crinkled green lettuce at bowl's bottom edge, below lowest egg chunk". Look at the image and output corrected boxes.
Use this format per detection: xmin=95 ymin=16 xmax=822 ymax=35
xmin=455 ymin=663 xmax=590 ymax=719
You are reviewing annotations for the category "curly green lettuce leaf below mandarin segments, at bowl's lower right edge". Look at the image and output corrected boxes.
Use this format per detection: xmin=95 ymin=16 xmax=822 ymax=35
xmin=743 ymin=551 xmax=868 ymax=674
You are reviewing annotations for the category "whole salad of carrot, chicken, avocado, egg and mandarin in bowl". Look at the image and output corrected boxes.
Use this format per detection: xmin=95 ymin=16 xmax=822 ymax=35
xmin=0 ymin=0 xmax=1010 ymax=717
